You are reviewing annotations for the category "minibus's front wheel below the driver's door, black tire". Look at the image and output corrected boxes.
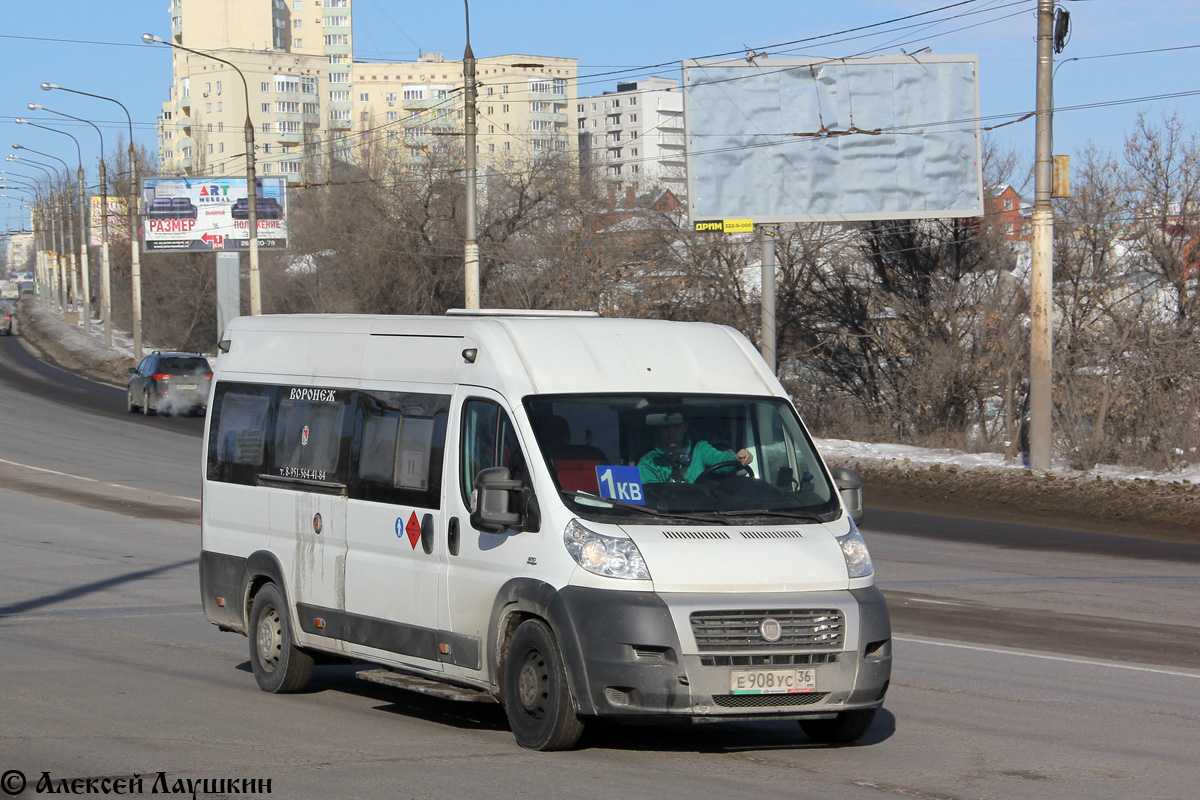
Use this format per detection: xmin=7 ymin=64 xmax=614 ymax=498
xmin=504 ymin=619 xmax=583 ymax=751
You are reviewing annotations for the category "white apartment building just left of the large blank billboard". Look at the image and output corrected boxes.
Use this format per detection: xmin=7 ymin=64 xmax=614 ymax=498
xmin=576 ymin=78 xmax=688 ymax=201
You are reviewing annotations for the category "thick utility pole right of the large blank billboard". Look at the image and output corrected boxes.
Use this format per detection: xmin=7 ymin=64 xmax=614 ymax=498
xmin=1030 ymin=0 xmax=1055 ymax=471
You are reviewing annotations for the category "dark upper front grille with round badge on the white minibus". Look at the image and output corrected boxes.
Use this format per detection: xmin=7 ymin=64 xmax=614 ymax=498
xmin=691 ymin=608 xmax=846 ymax=651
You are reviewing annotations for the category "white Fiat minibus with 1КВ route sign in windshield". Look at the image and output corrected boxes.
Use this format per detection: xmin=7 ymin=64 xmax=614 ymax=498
xmin=200 ymin=311 xmax=892 ymax=750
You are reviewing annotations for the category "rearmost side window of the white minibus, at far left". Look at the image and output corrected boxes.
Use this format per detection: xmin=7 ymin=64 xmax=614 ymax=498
xmin=208 ymin=381 xmax=275 ymax=486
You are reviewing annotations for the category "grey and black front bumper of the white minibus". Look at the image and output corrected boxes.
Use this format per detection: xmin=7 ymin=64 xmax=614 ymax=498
xmin=550 ymin=585 xmax=892 ymax=721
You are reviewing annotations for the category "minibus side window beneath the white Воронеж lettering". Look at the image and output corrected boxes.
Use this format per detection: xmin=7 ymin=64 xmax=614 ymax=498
xmin=271 ymin=387 xmax=352 ymax=483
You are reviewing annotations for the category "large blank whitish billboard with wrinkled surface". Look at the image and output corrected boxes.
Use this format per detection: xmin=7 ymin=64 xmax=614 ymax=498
xmin=683 ymin=55 xmax=983 ymax=223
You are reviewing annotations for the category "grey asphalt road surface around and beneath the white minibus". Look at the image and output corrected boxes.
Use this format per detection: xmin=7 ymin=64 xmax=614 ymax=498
xmin=0 ymin=338 xmax=1200 ymax=800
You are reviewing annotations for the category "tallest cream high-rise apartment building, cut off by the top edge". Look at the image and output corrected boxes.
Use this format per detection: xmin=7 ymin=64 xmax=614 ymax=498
xmin=158 ymin=0 xmax=354 ymax=181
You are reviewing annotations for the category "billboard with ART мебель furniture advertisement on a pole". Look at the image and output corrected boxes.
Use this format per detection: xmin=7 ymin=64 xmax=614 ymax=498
xmin=140 ymin=178 xmax=288 ymax=253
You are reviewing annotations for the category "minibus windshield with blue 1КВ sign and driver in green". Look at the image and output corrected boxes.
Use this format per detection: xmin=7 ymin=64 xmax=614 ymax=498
xmin=526 ymin=395 xmax=840 ymax=524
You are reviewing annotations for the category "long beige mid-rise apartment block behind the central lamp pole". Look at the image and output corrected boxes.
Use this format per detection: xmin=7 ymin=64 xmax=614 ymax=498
xmin=352 ymin=53 xmax=577 ymax=172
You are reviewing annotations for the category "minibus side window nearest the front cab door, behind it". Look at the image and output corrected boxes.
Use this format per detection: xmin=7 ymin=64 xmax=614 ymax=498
xmin=349 ymin=391 xmax=450 ymax=509
